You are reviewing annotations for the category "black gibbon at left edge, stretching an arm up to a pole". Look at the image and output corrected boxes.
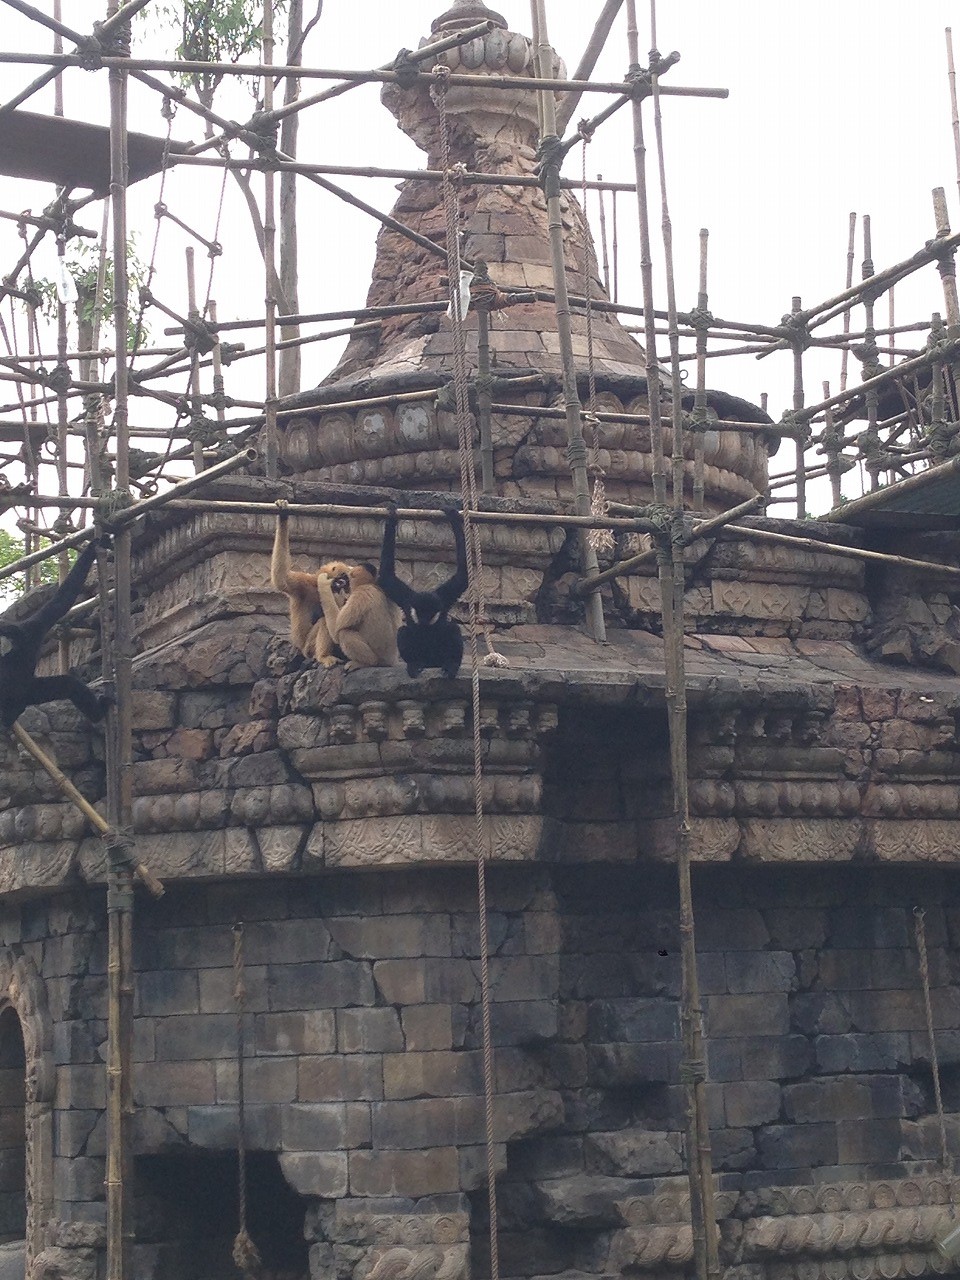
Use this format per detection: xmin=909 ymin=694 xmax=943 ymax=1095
xmin=0 ymin=543 xmax=114 ymax=728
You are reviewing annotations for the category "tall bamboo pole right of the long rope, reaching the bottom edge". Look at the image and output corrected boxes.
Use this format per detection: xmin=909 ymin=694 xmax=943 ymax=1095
xmin=644 ymin=15 xmax=719 ymax=1280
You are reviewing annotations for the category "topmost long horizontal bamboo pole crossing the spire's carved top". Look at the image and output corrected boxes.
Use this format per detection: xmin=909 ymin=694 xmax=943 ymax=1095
xmin=0 ymin=48 xmax=730 ymax=98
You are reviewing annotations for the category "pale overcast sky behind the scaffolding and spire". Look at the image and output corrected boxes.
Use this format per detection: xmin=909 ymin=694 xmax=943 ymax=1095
xmin=0 ymin=0 xmax=960 ymax=514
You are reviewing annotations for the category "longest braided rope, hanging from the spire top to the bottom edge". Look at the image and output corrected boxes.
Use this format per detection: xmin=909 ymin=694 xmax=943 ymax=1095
xmin=431 ymin=67 xmax=500 ymax=1280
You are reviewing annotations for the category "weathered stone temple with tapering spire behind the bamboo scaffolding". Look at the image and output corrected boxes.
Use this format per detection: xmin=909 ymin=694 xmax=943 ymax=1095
xmin=0 ymin=3 xmax=960 ymax=1280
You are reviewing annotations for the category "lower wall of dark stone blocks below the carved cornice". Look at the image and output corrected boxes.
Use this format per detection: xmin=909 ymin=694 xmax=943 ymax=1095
xmin=0 ymin=865 xmax=960 ymax=1280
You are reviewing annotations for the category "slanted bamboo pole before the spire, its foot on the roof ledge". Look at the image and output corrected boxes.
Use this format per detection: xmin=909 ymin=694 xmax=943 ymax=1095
xmin=530 ymin=0 xmax=607 ymax=641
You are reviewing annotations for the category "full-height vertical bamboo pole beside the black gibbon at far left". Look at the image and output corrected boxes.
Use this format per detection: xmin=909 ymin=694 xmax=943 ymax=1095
xmin=106 ymin=0 xmax=133 ymax=1280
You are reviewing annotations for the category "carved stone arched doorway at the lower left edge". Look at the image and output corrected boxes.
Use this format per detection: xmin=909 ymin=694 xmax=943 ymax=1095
xmin=0 ymin=951 xmax=55 ymax=1275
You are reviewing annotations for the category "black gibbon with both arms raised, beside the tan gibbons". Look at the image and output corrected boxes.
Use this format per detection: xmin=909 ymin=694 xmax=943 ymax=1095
xmin=379 ymin=503 xmax=468 ymax=677
